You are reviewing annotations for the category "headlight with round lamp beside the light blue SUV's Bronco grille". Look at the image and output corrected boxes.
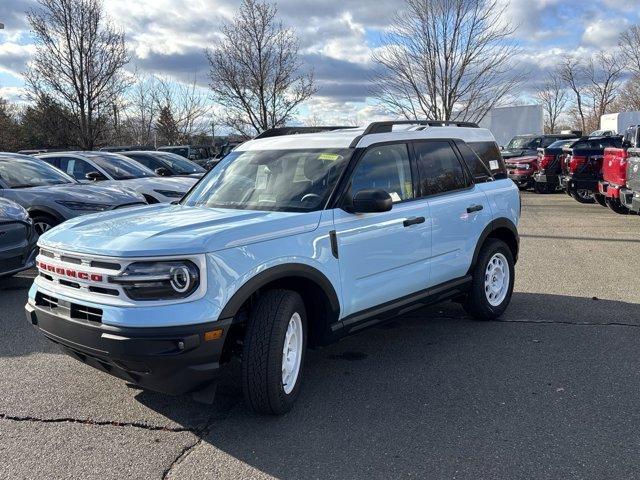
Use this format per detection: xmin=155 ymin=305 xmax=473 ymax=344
xmin=109 ymin=260 xmax=200 ymax=300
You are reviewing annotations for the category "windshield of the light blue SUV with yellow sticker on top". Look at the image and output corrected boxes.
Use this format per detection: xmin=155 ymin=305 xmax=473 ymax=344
xmin=182 ymin=149 xmax=353 ymax=212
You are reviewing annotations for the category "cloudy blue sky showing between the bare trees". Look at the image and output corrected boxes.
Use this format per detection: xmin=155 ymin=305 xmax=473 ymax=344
xmin=0 ymin=0 xmax=640 ymax=123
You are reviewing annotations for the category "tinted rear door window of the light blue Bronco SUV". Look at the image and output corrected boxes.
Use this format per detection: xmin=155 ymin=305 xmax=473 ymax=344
xmin=415 ymin=142 xmax=471 ymax=195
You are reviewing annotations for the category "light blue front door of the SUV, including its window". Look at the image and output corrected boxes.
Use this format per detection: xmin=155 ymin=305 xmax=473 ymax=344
xmin=334 ymin=143 xmax=431 ymax=317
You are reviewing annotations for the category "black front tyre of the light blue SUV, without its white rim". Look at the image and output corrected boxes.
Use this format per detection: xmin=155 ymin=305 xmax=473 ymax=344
xmin=242 ymin=289 xmax=307 ymax=415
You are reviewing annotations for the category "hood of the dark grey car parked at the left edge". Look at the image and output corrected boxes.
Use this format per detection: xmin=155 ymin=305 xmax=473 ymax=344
xmin=12 ymin=183 xmax=144 ymax=206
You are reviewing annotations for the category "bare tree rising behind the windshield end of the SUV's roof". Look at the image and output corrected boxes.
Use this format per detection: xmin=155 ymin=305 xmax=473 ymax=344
xmin=206 ymin=0 xmax=316 ymax=134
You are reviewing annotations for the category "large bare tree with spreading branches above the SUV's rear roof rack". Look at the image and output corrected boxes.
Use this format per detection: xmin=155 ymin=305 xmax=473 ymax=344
xmin=372 ymin=0 xmax=520 ymax=121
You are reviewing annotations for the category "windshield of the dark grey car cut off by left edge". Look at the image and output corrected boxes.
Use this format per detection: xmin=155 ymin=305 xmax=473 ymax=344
xmin=0 ymin=158 xmax=77 ymax=188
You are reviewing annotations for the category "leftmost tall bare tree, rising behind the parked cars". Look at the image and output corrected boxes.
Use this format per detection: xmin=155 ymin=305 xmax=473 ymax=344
xmin=25 ymin=0 xmax=129 ymax=149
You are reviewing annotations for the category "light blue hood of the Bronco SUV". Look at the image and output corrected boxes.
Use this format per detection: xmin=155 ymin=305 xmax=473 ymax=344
xmin=40 ymin=204 xmax=321 ymax=257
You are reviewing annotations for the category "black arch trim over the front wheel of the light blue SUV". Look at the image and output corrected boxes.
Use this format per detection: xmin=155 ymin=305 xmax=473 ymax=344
xmin=219 ymin=263 xmax=340 ymax=318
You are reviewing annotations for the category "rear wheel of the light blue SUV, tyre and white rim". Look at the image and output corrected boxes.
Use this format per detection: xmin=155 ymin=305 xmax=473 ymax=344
xmin=463 ymin=238 xmax=515 ymax=320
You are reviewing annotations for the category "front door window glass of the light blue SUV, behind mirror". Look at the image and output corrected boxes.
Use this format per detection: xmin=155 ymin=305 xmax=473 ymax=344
xmin=351 ymin=143 xmax=413 ymax=203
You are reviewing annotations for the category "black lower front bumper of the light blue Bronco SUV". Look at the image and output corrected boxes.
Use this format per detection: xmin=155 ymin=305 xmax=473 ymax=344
xmin=25 ymin=300 xmax=233 ymax=395
